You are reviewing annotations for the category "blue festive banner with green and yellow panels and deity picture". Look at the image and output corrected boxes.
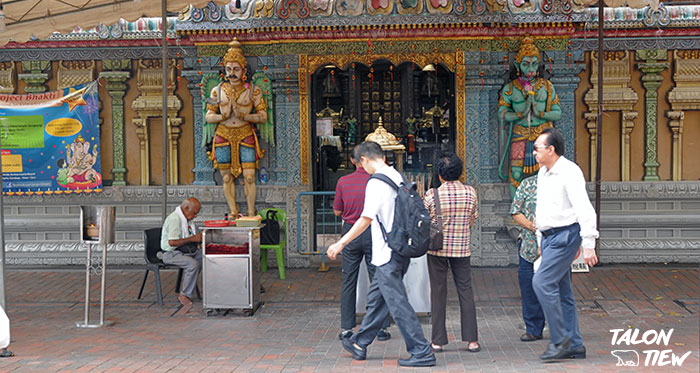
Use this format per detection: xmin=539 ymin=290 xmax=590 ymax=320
xmin=0 ymin=82 xmax=102 ymax=196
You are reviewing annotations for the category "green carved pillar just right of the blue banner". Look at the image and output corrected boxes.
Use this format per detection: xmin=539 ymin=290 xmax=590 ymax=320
xmin=100 ymin=60 xmax=131 ymax=185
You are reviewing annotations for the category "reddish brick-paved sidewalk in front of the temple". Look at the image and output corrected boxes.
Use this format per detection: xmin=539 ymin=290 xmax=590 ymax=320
xmin=0 ymin=263 xmax=700 ymax=373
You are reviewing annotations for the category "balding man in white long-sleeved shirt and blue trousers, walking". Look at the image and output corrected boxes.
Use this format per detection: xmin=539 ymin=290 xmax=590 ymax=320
xmin=532 ymin=128 xmax=598 ymax=361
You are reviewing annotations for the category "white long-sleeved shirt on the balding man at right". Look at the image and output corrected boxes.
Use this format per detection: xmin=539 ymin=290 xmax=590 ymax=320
xmin=535 ymin=156 xmax=598 ymax=249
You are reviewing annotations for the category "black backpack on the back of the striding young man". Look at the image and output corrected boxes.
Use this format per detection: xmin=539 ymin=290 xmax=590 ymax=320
xmin=370 ymin=173 xmax=430 ymax=258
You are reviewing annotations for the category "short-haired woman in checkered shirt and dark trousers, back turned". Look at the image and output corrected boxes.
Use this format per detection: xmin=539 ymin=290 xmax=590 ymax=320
xmin=424 ymin=152 xmax=481 ymax=352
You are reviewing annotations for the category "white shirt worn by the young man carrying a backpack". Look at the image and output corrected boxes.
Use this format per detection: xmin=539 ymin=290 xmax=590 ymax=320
xmin=362 ymin=165 xmax=403 ymax=266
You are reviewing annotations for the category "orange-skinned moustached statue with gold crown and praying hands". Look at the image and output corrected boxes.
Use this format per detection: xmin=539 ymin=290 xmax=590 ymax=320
xmin=202 ymin=38 xmax=274 ymax=218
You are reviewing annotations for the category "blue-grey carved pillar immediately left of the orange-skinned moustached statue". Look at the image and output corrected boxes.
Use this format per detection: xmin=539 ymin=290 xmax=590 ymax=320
xmin=182 ymin=57 xmax=219 ymax=185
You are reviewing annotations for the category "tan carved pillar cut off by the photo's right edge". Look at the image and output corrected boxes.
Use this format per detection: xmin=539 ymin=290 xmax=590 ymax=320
xmin=666 ymin=50 xmax=700 ymax=181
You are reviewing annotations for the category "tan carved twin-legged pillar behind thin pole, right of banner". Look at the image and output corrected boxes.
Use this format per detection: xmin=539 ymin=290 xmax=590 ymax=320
xmin=131 ymin=59 xmax=182 ymax=185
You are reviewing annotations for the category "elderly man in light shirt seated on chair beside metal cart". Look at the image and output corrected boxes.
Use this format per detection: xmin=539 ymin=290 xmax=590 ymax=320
xmin=160 ymin=198 xmax=202 ymax=312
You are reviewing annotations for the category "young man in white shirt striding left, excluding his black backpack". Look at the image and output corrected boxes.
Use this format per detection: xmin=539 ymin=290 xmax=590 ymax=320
xmin=326 ymin=141 xmax=435 ymax=367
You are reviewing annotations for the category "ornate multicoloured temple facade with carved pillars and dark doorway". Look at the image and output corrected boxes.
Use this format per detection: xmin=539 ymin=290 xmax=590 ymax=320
xmin=0 ymin=0 xmax=700 ymax=267
